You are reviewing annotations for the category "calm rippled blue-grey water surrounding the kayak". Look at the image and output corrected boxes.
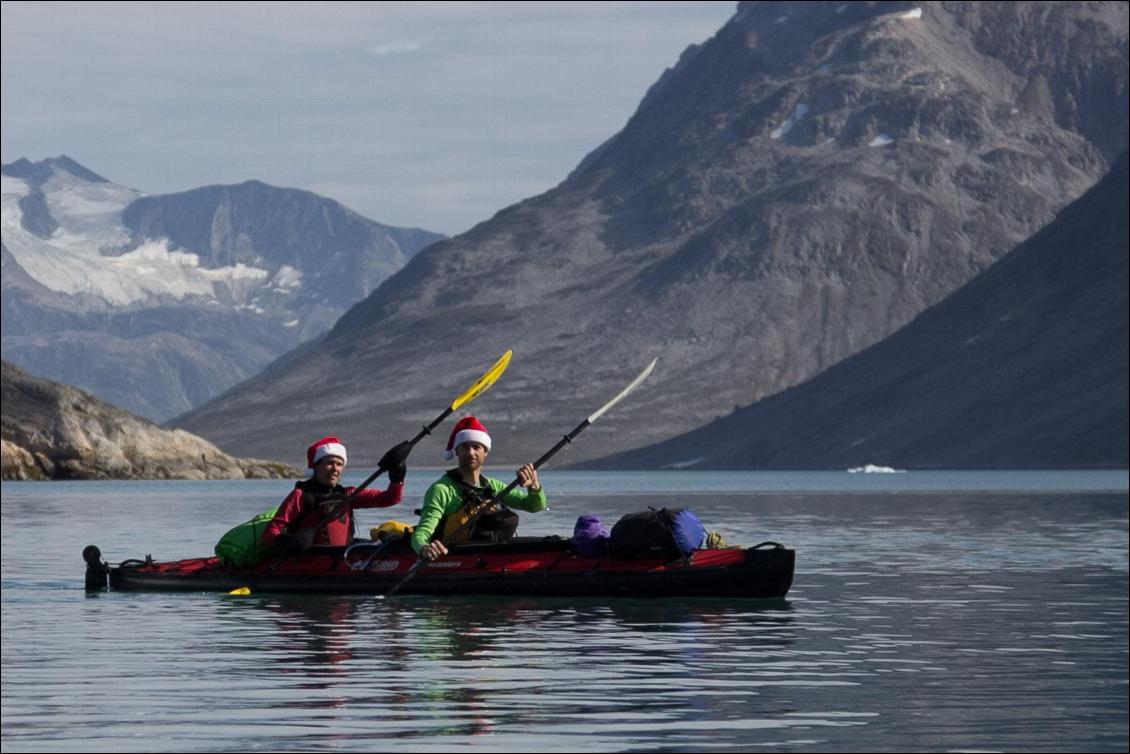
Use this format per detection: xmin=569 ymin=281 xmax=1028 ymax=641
xmin=0 ymin=471 xmax=1128 ymax=752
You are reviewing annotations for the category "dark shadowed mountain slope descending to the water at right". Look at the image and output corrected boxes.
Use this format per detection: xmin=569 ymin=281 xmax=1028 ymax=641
xmin=591 ymin=154 xmax=1130 ymax=469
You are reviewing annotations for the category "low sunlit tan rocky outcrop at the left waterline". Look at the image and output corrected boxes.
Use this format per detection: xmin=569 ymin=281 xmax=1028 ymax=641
xmin=0 ymin=362 xmax=299 ymax=479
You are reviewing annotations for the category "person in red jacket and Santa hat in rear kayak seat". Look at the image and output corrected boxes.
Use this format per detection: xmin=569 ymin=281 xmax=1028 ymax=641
xmin=263 ymin=436 xmax=411 ymax=555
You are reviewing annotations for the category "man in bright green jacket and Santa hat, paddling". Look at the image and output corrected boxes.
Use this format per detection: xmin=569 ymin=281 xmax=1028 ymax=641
xmin=411 ymin=416 xmax=546 ymax=561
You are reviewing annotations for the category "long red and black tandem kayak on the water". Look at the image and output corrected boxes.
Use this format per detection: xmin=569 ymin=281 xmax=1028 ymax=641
xmin=82 ymin=537 xmax=796 ymax=598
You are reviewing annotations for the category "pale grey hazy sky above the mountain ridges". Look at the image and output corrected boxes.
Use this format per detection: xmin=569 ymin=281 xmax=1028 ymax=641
xmin=0 ymin=0 xmax=737 ymax=235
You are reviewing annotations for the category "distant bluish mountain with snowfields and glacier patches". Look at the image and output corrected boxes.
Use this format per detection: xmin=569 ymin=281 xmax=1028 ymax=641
xmin=2 ymin=156 xmax=443 ymax=421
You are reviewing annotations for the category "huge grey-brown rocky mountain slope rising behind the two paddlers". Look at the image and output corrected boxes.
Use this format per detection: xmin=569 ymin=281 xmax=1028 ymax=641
xmin=171 ymin=2 xmax=1128 ymax=463
